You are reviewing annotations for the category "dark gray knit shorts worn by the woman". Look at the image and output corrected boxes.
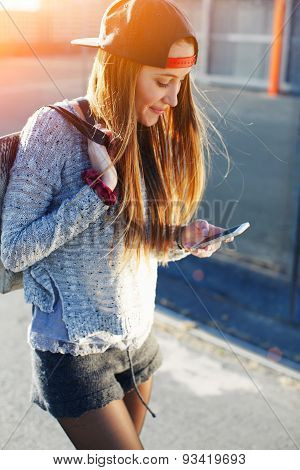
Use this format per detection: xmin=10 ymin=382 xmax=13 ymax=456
xmin=30 ymin=326 xmax=163 ymax=418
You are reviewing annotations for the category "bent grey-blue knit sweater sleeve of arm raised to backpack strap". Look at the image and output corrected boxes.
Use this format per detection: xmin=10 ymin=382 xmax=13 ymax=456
xmin=0 ymin=103 xmax=109 ymax=272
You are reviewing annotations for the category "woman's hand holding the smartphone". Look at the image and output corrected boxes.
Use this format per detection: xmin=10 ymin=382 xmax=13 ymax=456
xmin=181 ymin=219 xmax=234 ymax=258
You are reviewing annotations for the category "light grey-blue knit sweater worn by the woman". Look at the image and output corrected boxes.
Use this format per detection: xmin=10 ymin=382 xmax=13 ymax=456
xmin=1 ymin=99 xmax=189 ymax=352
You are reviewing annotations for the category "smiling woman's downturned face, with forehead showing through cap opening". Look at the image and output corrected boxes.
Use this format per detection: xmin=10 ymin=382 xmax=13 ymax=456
xmin=135 ymin=42 xmax=195 ymax=127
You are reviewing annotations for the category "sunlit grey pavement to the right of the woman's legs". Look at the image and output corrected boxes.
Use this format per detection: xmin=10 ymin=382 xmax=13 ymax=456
xmin=149 ymin=308 xmax=300 ymax=450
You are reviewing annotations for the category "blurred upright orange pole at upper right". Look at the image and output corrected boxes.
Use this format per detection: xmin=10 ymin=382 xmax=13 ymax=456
xmin=268 ymin=0 xmax=285 ymax=95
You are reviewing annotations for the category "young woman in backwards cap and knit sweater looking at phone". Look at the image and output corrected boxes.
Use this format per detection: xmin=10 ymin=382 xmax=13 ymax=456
xmin=1 ymin=0 xmax=231 ymax=449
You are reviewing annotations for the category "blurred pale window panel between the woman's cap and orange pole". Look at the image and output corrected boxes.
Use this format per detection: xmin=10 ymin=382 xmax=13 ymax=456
xmin=208 ymin=0 xmax=274 ymax=80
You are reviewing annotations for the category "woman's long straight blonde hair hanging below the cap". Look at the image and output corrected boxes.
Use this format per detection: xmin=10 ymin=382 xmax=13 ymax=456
xmin=86 ymin=38 xmax=227 ymax=274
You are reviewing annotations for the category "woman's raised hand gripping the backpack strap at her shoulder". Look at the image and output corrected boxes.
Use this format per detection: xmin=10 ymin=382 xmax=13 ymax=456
xmin=88 ymin=124 xmax=118 ymax=191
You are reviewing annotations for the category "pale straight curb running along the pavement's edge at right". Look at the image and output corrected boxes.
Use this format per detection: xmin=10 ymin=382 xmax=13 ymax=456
xmin=154 ymin=304 xmax=300 ymax=381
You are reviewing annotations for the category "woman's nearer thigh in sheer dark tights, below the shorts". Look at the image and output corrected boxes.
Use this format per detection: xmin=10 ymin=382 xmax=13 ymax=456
xmin=57 ymin=400 xmax=144 ymax=450
